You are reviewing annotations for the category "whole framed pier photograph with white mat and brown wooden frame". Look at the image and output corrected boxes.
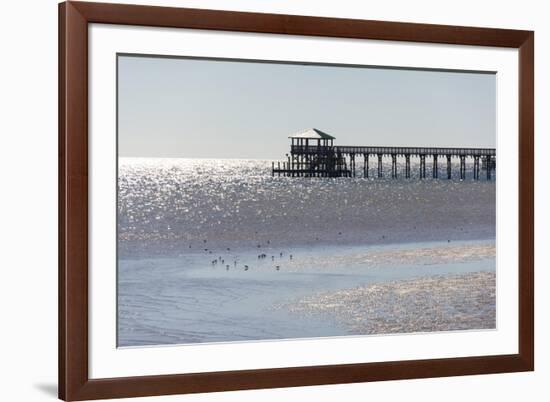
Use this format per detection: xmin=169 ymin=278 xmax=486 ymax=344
xmin=59 ymin=1 xmax=534 ymax=400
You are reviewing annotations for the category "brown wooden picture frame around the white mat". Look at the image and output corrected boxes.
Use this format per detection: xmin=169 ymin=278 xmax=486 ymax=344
xmin=59 ymin=1 xmax=534 ymax=400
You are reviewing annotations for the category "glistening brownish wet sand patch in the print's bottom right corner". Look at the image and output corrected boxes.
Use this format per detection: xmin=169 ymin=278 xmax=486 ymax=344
xmin=279 ymin=272 xmax=496 ymax=335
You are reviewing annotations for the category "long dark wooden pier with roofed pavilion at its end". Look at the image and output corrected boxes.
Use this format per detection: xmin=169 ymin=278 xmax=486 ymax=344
xmin=271 ymin=128 xmax=496 ymax=180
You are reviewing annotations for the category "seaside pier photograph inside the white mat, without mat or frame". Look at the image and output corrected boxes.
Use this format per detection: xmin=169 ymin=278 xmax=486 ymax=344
xmin=117 ymin=54 xmax=497 ymax=347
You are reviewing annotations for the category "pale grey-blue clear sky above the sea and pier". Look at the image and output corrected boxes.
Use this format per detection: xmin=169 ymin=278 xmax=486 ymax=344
xmin=118 ymin=56 xmax=496 ymax=160
